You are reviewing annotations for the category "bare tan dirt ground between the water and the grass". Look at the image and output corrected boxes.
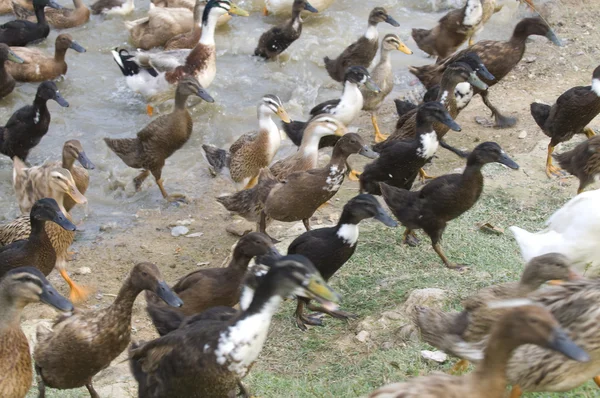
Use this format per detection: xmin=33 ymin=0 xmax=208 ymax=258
xmin=18 ymin=0 xmax=600 ymax=397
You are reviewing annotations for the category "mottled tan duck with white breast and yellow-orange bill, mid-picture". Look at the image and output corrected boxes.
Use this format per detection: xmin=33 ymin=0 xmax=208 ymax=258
xmin=202 ymin=94 xmax=290 ymax=190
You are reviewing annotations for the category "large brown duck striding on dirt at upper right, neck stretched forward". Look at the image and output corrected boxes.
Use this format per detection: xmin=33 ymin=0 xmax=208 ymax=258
xmin=409 ymin=18 xmax=562 ymax=128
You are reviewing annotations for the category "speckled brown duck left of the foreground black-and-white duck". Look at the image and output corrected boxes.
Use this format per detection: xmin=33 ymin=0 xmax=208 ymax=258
xmin=33 ymin=263 xmax=183 ymax=397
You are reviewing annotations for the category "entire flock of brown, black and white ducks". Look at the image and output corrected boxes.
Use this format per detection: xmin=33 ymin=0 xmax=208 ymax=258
xmin=0 ymin=0 xmax=600 ymax=398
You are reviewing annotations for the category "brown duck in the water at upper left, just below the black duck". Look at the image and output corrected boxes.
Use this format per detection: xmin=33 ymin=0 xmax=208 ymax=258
xmin=6 ymin=33 xmax=85 ymax=82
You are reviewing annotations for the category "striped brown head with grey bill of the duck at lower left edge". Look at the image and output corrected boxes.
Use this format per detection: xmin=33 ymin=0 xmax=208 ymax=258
xmin=0 ymin=267 xmax=73 ymax=312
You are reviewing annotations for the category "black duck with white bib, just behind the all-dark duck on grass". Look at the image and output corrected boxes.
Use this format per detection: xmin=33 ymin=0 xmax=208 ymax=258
xmin=359 ymin=101 xmax=461 ymax=195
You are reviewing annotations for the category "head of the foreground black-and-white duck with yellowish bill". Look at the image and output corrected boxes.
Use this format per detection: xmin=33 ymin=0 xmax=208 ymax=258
xmin=270 ymin=254 xmax=340 ymax=311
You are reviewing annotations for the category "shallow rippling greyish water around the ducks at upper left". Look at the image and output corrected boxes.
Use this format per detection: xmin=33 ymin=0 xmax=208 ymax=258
xmin=0 ymin=0 xmax=518 ymax=239
